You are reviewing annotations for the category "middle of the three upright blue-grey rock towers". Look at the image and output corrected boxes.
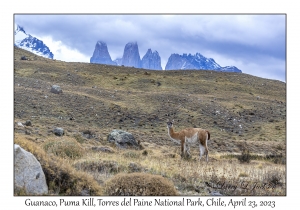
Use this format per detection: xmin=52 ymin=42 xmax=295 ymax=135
xmin=122 ymin=42 xmax=141 ymax=68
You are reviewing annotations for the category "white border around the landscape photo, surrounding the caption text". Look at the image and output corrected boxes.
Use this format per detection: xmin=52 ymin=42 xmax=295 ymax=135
xmin=0 ymin=0 xmax=300 ymax=209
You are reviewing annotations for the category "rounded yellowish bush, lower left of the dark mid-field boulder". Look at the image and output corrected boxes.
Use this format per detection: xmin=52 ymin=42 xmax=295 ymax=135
xmin=44 ymin=137 xmax=84 ymax=158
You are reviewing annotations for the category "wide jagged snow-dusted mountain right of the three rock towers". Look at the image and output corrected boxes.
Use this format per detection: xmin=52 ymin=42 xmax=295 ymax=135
xmin=165 ymin=53 xmax=242 ymax=73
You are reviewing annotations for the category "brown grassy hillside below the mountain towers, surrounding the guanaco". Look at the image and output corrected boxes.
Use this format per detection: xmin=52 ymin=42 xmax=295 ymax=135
xmin=14 ymin=48 xmax=286 ymax=194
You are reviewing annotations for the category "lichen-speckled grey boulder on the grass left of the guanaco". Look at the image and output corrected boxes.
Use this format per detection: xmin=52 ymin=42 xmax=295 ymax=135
xmin=107 ymin=130 xmax=139 ymax=148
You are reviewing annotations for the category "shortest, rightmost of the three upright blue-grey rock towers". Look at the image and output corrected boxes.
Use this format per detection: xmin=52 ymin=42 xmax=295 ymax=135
xmin=142 ymin=49 xmax=162 ymax=70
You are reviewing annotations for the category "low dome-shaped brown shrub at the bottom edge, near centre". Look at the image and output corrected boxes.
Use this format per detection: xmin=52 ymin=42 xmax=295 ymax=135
xmin=105 ymin=173 xmax=178 ymax=196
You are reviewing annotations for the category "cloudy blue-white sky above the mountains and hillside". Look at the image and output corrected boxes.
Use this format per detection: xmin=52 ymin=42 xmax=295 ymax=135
xmin=14 ymin=14 xmax=286 ymax=82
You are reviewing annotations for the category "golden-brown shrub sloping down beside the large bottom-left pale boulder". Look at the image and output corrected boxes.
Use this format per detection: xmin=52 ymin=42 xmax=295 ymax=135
xmin=14 ymin=135 xmax=102 ymax=196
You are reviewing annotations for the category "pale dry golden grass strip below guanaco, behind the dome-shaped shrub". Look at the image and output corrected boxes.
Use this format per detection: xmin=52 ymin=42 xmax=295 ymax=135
xmin=67 ymin=144 xmax=286 ymax=195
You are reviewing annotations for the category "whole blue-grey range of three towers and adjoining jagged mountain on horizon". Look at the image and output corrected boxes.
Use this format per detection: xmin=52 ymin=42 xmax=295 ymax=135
xmin=90 ymin=41 xmax=242 ymax=73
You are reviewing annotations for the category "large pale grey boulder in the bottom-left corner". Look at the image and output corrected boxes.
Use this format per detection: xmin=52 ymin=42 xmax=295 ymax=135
xmin=14 ymin=144 xmax=48 ymax=195
